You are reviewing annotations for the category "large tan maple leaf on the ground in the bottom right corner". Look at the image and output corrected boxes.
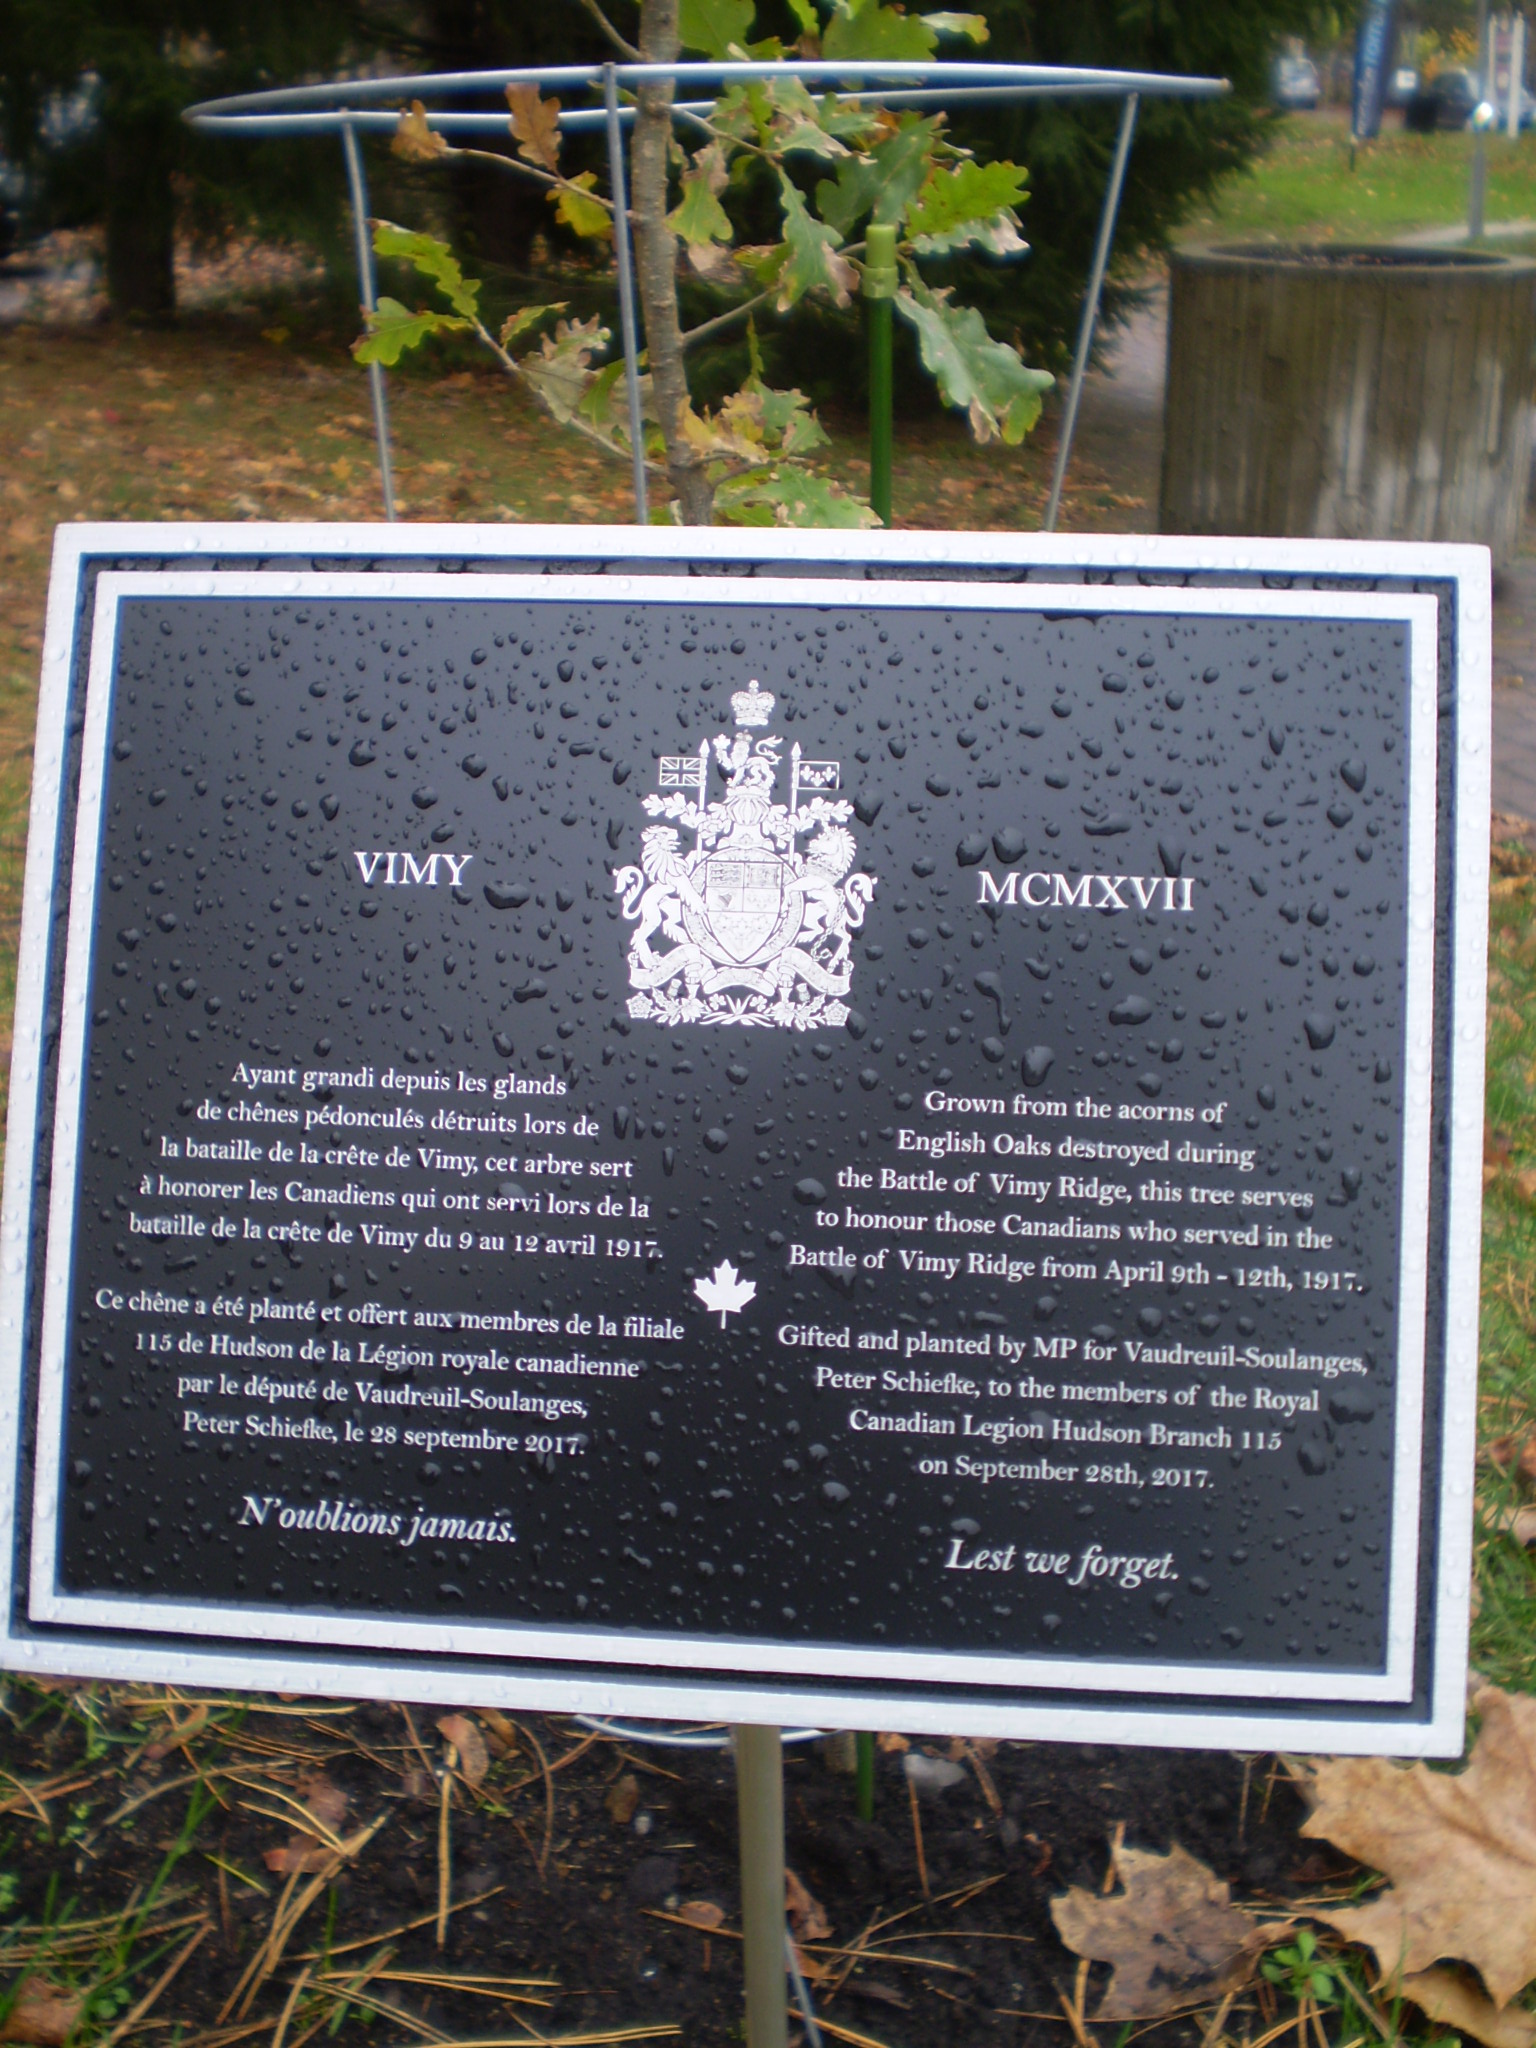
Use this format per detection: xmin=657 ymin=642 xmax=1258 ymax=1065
xmin=1300 ymin=1686 xmax=1536 ymax=2005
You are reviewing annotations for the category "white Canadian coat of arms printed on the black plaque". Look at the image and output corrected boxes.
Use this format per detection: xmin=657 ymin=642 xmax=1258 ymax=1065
xmin=614 ymin=680 xmax=874 ymax=1030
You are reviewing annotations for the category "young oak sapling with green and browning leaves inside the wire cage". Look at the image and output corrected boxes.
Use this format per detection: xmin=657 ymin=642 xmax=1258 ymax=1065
xmin=354 ymin=0 xmax=1053 ymax=526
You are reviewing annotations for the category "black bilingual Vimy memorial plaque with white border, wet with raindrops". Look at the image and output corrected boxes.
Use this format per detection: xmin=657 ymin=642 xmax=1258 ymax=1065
xmin=6 ymin=528 xmax=1487 ymax=1753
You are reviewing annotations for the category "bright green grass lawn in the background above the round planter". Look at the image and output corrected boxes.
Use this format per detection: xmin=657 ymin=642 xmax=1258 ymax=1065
xmin=1180 ymin=113 xmax=1536 ymax=242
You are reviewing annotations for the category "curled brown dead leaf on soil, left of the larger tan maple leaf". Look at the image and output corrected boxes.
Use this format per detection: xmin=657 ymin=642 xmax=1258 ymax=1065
xmin=1051 ymin=1843 xmax=1290 ymax=2019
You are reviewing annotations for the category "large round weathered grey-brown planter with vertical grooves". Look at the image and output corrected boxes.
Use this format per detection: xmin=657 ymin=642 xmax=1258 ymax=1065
xmin=1161 ymin=246 xmax=1536 ymax=565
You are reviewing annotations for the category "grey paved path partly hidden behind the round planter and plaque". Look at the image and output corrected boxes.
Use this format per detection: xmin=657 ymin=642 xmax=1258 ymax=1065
xmin=1073 ymin=287 xmax=1536 ymax=838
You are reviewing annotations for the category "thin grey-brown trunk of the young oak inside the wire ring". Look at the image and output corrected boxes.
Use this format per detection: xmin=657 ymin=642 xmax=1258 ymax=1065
xmin=631 ymin=0 xmax=715 ymax=526
